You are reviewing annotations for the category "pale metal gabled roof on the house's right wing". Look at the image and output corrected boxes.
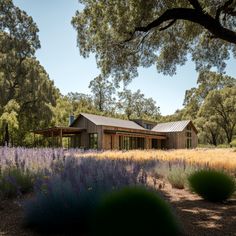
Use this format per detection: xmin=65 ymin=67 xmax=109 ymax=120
xmin=152 ymin=120 xmax=197 ymax=133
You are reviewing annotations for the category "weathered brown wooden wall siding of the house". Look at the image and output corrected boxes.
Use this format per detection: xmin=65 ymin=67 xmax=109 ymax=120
xmin=73 ymin=116 xmax=198 ymax=150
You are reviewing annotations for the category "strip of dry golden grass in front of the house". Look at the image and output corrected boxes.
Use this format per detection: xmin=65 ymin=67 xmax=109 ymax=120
xmin=79 ymin=148 xmax=236 ymax=171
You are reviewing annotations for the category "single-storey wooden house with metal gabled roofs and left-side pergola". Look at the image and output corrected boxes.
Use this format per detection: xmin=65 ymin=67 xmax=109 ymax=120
xmin=34 ymin=113 xmax=198 ymax=150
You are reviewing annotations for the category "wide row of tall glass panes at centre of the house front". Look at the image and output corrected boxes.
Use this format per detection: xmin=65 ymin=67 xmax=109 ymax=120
xmin=119 ymin=136 xmax=145 ymax=150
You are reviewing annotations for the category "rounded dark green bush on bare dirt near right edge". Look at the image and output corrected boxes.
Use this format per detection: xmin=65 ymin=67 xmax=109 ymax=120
xmin=188 ymin=170 xmax=235 ymax=202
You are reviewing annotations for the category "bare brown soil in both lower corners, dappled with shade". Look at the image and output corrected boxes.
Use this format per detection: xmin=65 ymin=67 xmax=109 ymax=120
xmin=0 ymin=182 xmax=236 ymax=236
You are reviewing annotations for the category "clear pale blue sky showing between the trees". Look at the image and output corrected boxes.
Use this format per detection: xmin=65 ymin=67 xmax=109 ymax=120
xmin=13 ymin=0 xmax=236 ymax=115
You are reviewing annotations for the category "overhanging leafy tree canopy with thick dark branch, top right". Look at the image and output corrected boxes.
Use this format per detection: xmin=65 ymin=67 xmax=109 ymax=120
xmin=72 ymin=0 xmax=236 ymax=84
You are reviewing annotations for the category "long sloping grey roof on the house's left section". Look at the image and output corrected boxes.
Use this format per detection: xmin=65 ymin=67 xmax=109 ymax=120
xmin=80 ymin=113 xmax=146 ymax=130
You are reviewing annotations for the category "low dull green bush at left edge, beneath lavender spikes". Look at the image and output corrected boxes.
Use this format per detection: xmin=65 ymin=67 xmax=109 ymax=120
xmin=0 ymin=167 xmax=34 ymax=198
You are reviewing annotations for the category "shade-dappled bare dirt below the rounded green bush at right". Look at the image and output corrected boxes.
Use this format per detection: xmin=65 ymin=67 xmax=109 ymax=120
xmin=162 ymin=190 xmax=236 ymax=236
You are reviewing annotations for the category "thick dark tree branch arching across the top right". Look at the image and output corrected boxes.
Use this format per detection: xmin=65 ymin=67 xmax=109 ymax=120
xmin=130 ymin=8 xmax=236 ymax=44
